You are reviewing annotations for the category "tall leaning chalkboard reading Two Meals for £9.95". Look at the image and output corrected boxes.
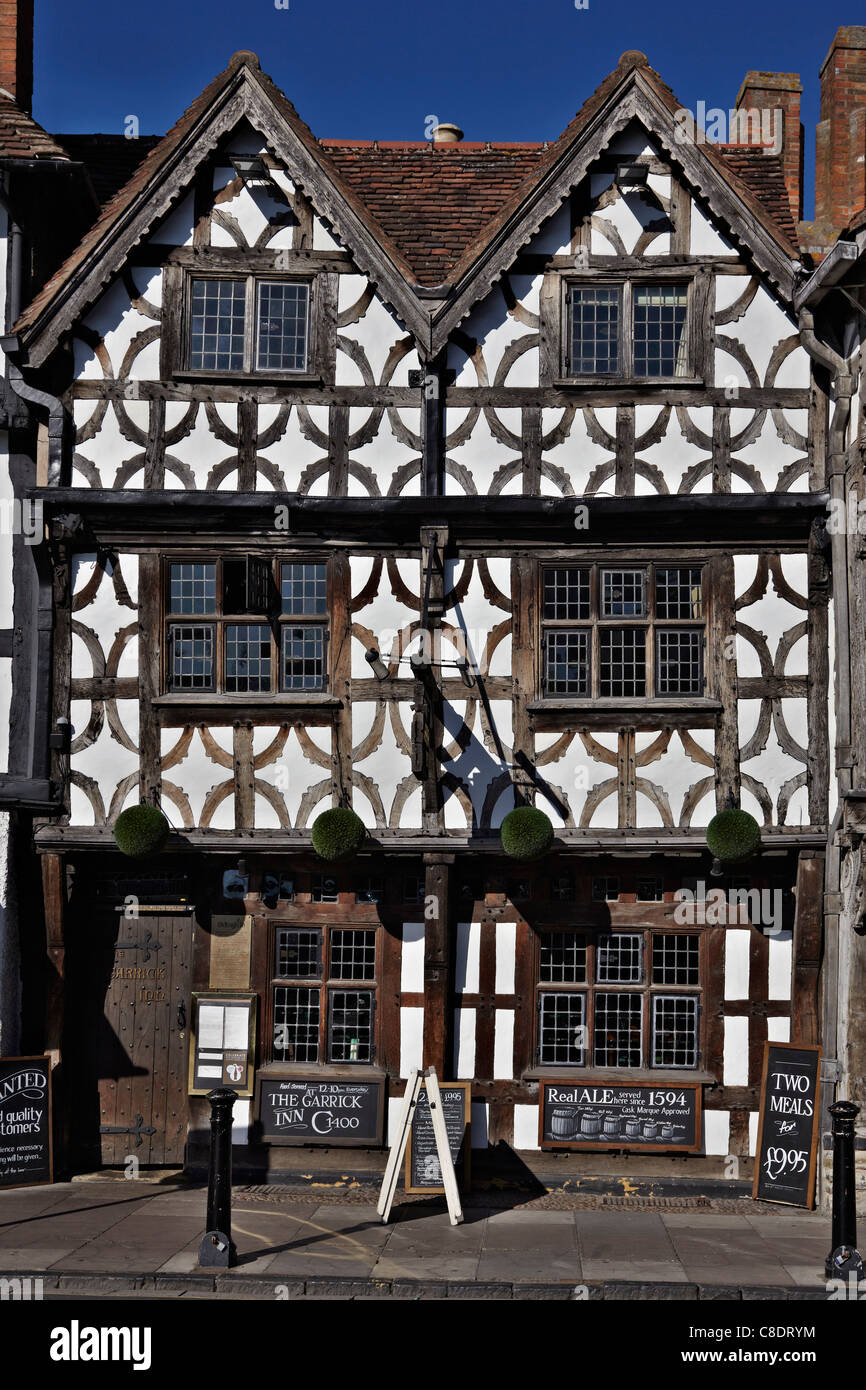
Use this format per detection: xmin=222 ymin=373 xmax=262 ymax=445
xmin=752 ymin=1043 xmax=822 ymax=1208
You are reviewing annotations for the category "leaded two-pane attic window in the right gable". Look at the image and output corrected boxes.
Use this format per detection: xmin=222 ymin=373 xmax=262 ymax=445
xmin=564 ymin=279 xmax=694 ymax=381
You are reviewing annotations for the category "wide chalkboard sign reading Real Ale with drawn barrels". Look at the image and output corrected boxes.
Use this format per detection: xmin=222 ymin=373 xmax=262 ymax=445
xmin=538 ymin=1081 xmax=701 ymax=1154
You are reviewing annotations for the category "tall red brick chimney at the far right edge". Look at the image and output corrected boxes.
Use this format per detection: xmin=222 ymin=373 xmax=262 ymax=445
xmin=815 ymin=24 xmax=866 ymax=236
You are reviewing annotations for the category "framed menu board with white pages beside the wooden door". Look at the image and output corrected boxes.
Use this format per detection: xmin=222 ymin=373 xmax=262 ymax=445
xmin=189 ymin=990 xmax=256 ymax=1095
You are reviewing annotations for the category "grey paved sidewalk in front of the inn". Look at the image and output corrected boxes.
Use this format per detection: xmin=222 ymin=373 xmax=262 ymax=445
xmin=0 ymin=1180 xmax=830 ymax=1298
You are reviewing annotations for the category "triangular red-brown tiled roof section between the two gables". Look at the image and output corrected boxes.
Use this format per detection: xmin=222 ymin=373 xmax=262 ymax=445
xmin=321 ymin=140 xmax=544 ymax=286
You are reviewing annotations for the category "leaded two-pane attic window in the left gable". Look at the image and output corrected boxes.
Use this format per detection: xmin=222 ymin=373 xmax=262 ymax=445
xmin=188 ymin=275 xmax=310 ymax=374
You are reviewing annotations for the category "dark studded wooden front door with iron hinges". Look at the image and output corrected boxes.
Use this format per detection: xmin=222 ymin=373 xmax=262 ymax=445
xmin=64 ymin=910 xmax=192 ymax=1168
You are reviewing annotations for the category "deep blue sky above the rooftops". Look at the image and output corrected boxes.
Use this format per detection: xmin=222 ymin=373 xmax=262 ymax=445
xmin=33 ymin=0 xmax=863 ymax=215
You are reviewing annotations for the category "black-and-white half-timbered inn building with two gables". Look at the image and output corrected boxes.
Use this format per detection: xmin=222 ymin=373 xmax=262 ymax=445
xmin=7 ymin=35 xmax=861 ymax=1177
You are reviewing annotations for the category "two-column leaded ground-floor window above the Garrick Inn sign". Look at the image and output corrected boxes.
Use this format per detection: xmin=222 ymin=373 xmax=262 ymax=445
xmin=271 ymin=927 xmax=377 ymax=1063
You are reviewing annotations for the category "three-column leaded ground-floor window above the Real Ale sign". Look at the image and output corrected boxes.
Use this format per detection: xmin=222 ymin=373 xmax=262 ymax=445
xmin=538 ymin=930 xmax=702 ymax=1069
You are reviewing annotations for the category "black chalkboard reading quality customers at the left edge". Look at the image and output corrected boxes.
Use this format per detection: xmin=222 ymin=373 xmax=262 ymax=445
xmin=0 ymin=1056 xmax=53 ymax=1187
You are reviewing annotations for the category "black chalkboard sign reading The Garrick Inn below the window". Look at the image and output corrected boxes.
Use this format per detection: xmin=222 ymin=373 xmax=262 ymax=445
xmin=256 ymin=1074 xmax=385 ymax=1144
